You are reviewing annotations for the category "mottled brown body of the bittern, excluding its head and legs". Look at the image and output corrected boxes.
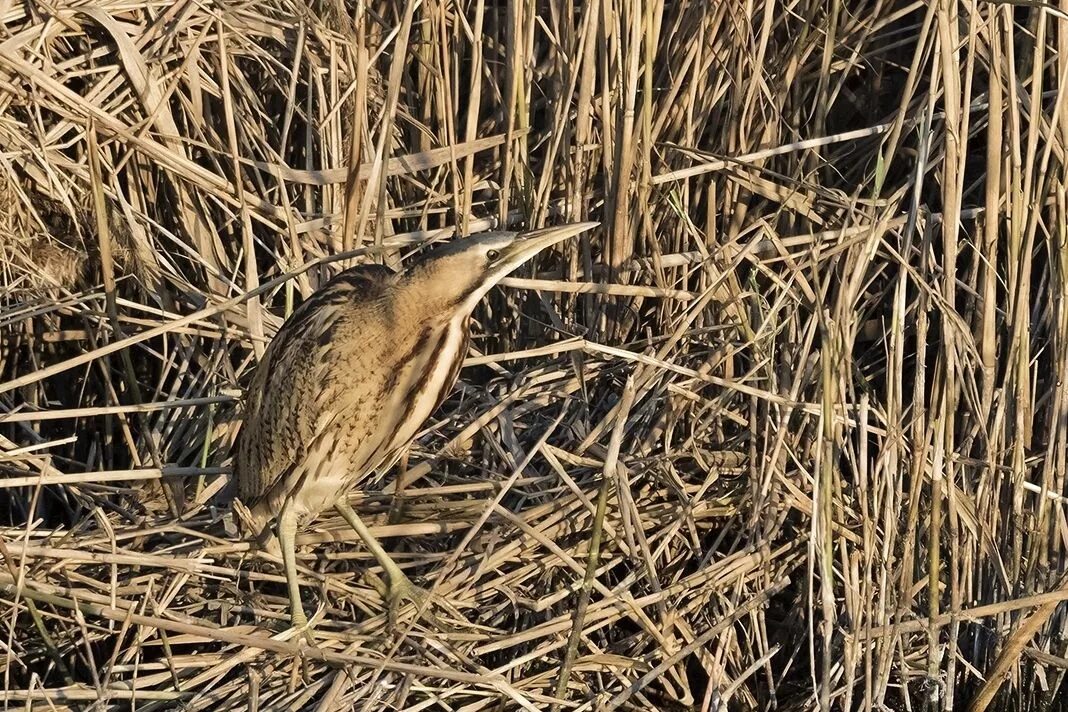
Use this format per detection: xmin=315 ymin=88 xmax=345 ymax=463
xmin=237 ymin=260 xmax=468 ymax=533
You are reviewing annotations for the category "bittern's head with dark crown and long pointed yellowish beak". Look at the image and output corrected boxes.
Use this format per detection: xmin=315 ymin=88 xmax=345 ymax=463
xmin=403 ymin=222 xmax=598 ymax=312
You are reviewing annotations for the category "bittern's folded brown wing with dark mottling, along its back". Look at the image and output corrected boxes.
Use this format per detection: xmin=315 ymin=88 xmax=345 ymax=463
xmin=235 ymin=265 xmax=394 ymax=507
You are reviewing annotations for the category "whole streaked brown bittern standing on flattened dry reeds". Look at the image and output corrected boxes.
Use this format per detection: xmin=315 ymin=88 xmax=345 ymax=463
xmin=234 ymin=222 xmax=597 ymax=627
